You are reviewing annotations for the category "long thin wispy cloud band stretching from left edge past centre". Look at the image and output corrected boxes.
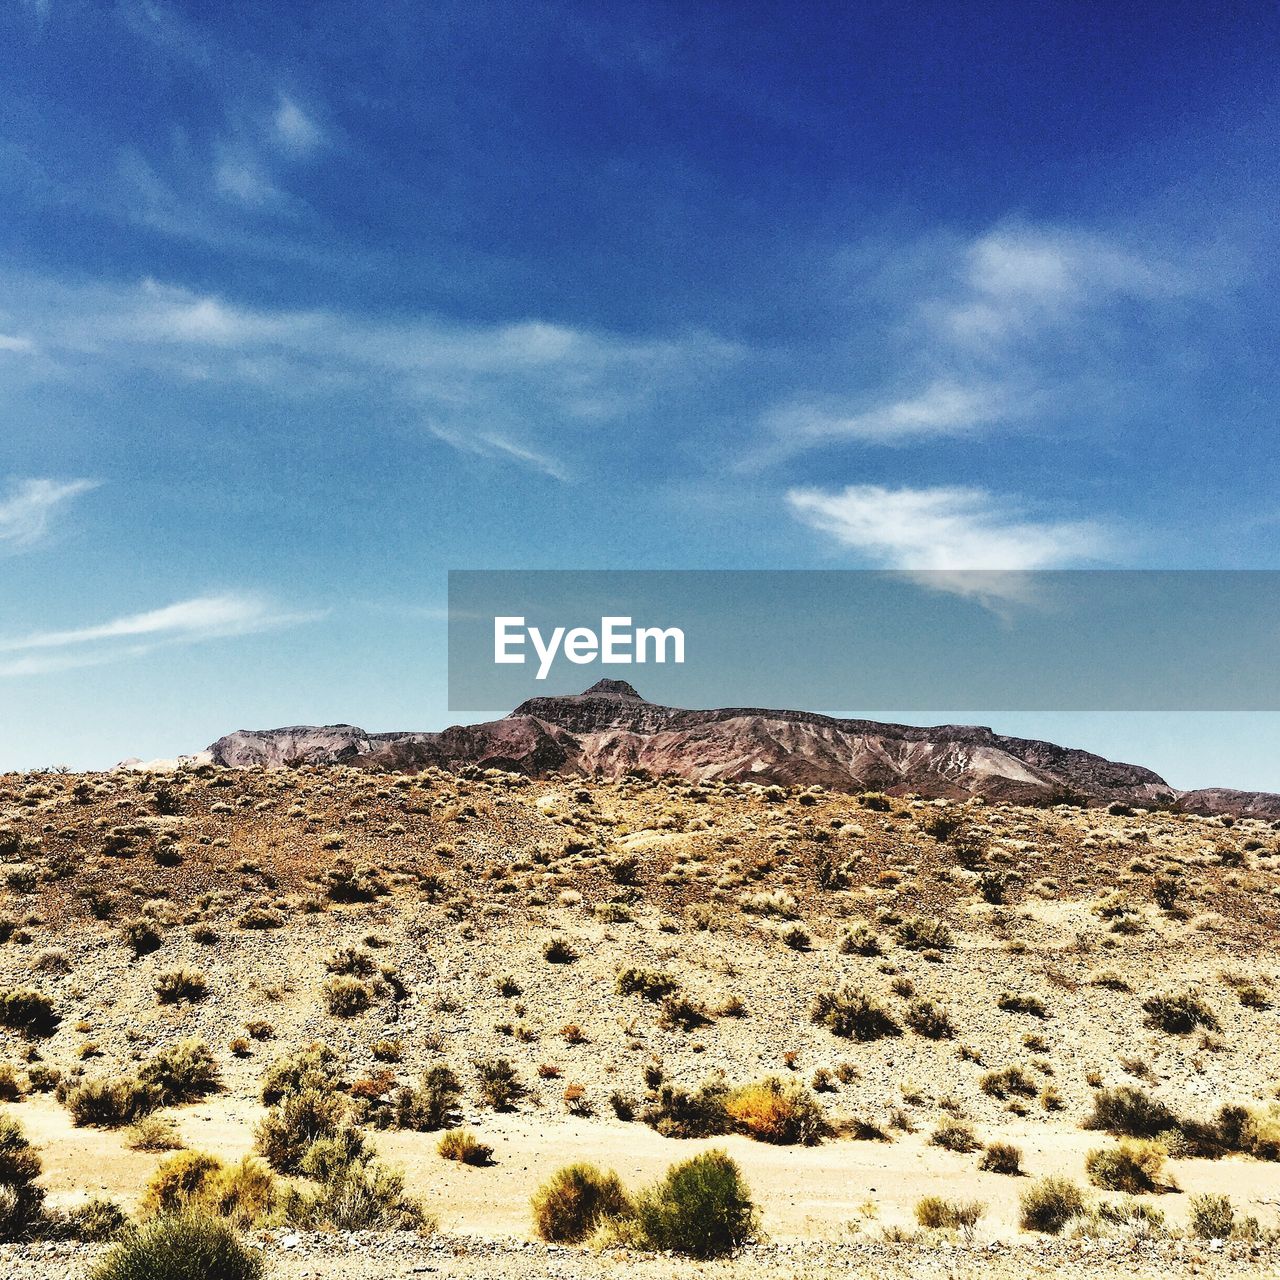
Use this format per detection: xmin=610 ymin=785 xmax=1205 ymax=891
xmin=0 ymin=278 xmax=737 ymax=480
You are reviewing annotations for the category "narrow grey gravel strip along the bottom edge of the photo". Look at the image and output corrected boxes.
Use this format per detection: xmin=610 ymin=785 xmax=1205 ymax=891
xmin=0 ymin=1231 xmax=1280 ymax=1280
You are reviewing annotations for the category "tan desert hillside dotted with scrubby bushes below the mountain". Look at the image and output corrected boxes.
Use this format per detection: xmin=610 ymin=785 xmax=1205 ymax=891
xmin=0 ymin=764 xmax=1280 ymax=1276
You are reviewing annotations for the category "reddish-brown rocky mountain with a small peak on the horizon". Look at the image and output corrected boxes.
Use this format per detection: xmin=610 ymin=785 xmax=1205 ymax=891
xmin=199 ymin=680 xmax=1280 ymax=819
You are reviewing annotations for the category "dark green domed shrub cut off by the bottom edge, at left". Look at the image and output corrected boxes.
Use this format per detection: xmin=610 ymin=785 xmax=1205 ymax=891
xmin=91 ymin=1212 xmax=262 ymax=1280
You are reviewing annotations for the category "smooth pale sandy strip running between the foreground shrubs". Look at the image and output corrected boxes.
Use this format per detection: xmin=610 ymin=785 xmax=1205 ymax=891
xmin=15 ymin=1098 xmax=1280 ymax=1242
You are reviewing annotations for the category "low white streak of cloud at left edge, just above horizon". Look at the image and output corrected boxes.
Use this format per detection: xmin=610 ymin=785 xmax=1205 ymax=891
xmin=0 ymin=593 xmax=323 ymax=677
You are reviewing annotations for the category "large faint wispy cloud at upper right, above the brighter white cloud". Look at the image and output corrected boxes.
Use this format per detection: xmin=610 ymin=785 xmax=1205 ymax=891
xmin=742 ymin=225 xmax=1198 ymax=468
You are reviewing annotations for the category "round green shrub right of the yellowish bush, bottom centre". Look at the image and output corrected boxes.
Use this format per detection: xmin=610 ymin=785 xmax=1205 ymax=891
xmin=635 ymin=1151 xmax=756 ymax=1258
